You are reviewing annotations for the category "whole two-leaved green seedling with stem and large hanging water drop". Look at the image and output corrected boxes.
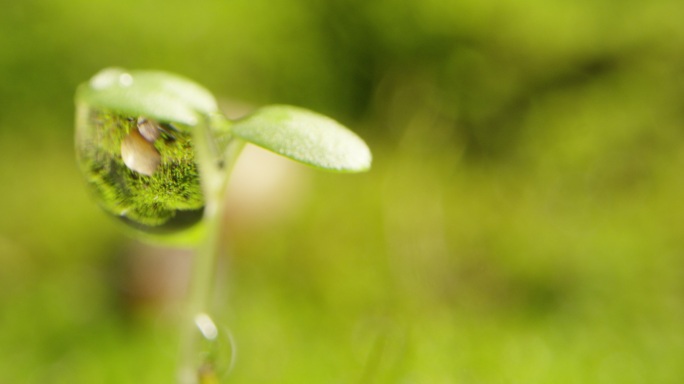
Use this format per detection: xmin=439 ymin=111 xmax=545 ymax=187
xmin=76 ymin=68 xmax=371 ymax=384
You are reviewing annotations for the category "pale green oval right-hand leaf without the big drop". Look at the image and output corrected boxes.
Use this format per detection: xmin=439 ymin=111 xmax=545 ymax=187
xmin=231 ymin=105 xmax=372 ymax=172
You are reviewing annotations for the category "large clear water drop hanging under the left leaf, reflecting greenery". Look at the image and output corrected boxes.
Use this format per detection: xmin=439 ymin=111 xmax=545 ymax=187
xmin=76 ymin=103 xmax=204 ymax=234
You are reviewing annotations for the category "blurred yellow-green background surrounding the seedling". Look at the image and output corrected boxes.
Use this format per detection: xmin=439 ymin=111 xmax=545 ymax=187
xmin=0 ymin=0 xmax=684 ymax=384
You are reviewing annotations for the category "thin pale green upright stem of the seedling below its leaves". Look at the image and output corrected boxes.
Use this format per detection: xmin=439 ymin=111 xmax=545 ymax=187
xmin=178 ymin=116 xmax=245 ymax=384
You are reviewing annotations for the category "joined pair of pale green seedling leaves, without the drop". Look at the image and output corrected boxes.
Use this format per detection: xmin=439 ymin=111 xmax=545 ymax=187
xmin=76 ymin=68 xmax=371 ymax=172
